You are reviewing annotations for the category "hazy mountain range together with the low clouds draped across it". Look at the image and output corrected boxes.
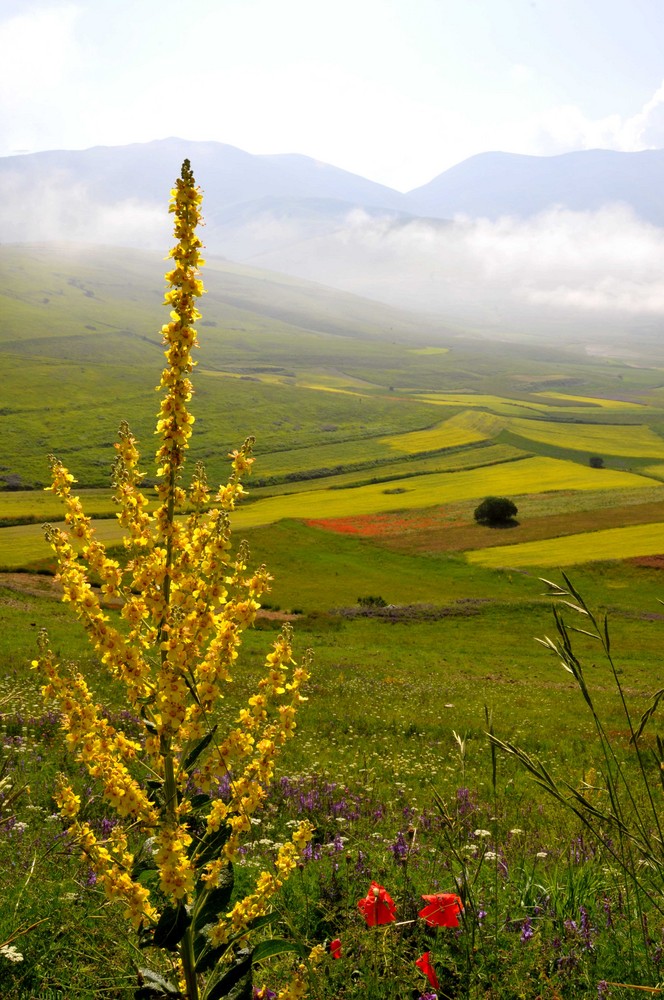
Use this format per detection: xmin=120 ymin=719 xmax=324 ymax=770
xmin=0 ymin=139 xmax=664 ymax=339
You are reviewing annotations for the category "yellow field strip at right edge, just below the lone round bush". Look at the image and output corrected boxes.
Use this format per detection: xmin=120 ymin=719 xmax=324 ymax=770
xmin=466 ymin=521 xmax=664 ymax=569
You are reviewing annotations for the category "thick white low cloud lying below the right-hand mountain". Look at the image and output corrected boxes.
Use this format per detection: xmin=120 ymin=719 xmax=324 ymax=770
xmin=245 ymin=205 xmax=664 ymax=332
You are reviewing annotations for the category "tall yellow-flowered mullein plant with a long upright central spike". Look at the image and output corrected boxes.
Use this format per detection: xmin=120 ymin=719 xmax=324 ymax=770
xmin=34 ymin=160 xmax=312 ymax=1000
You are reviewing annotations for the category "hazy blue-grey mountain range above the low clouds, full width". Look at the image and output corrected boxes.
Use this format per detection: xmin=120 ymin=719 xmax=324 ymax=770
xmin=0 ymin=138 xmax=664 ymax=242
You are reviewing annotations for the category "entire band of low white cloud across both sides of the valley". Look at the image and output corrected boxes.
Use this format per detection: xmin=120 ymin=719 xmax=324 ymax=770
xmin=0 ymin=165 xmax=664 ymax=336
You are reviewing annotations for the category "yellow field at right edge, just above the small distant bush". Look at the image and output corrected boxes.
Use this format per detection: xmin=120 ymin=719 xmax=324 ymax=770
xmin=509 ymin=418 xmax=664 ymax=460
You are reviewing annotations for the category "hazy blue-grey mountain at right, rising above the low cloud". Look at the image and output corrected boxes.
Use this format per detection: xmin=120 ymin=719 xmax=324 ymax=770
xmin=408 ymin=149 xmax=664 ymax=226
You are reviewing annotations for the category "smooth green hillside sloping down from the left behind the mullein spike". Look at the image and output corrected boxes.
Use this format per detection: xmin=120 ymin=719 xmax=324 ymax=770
xmin=0 ymin=245 xmax=464 ymax=489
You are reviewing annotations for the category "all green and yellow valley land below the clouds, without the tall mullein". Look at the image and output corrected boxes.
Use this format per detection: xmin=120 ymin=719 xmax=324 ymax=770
xmin=0 ymin=240 xmax=664 ymax=1000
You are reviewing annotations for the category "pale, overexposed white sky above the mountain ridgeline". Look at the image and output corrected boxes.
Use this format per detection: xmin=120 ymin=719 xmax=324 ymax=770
xmin=0 ymin=0 xmax=664 ymax=191
